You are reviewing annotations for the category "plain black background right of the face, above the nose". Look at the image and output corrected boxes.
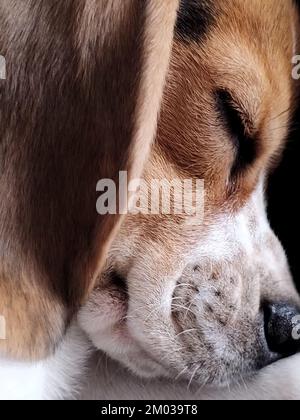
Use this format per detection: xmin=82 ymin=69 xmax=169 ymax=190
xmin=269 ymin=105 xmax=300 ymax=291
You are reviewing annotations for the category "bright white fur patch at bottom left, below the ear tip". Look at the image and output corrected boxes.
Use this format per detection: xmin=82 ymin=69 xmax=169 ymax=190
xmin=0 ymin=326 xmax=90 ymax=400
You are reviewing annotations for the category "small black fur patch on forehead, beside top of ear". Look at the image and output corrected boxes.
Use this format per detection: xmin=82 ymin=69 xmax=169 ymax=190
xmin=176 ymin=0 xmax=216 ymax=42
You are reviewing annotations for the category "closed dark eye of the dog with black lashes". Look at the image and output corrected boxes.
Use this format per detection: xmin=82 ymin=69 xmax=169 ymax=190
xmin=215 ymin=89 xmax=257 ymax=176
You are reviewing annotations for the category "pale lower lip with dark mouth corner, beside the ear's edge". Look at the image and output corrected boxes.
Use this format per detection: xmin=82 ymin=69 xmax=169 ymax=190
xmin=78 ymin=270 xmax=168 ymax=379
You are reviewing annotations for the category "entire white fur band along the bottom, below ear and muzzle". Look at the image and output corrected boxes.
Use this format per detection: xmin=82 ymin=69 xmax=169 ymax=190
xmin=0 ymin=327 xmax=300 ymax=401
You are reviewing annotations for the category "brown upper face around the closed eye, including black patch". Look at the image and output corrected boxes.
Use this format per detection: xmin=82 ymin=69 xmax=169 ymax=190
xmin=156 ymin=0 xmax=295 ymax=208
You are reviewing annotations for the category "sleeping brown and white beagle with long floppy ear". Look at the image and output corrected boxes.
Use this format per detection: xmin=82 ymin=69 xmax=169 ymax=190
xmin=0 ymin=0 xmax=300 ymax=399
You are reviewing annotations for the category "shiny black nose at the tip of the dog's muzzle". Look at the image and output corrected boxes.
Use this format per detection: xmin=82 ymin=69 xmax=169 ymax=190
xmin=265 ymin=303 xmax=300 ymax=357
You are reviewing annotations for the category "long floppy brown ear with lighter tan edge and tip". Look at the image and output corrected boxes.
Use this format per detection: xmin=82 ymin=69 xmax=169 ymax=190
xmin=0 ymin=0 xmax=178 ymax=359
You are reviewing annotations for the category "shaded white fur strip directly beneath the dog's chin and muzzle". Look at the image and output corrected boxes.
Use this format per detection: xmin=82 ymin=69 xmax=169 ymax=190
xmin=81 ymin=355 xmax=300 ymax=401
